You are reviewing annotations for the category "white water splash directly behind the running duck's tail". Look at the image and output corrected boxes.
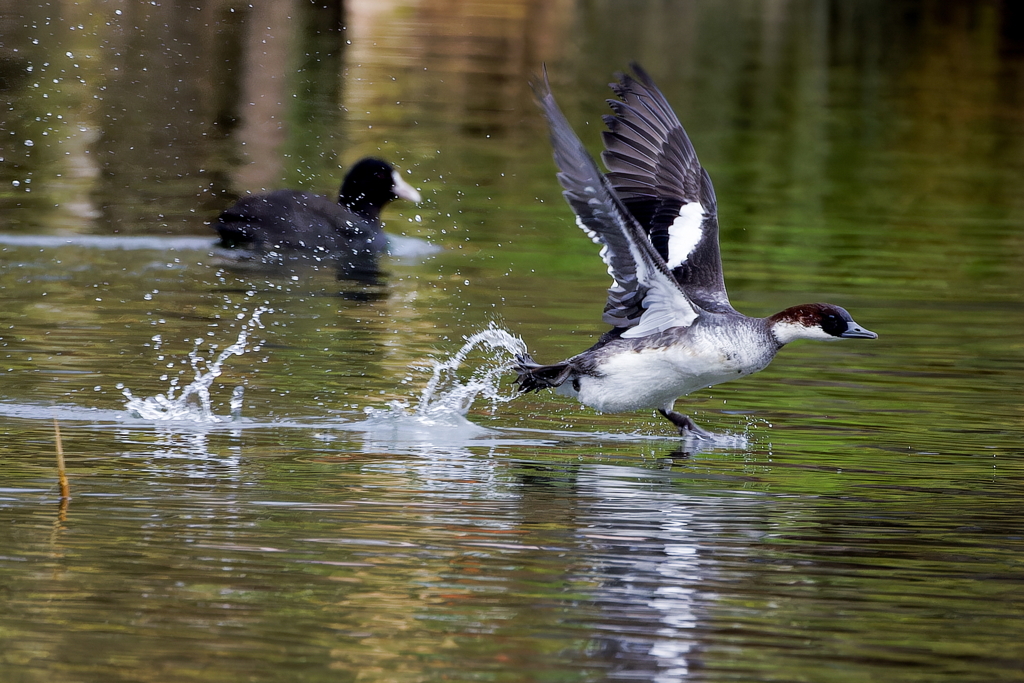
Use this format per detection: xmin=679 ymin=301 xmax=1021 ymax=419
xmin=357 ymin=324 xmax=526 ymax=439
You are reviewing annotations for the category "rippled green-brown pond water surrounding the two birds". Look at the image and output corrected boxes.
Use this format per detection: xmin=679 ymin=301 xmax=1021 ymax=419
xmin=0 ymin=0 xmax=1024 ymax=683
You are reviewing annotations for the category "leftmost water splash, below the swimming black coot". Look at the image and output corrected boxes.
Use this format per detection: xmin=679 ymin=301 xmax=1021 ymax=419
xmin=118 ymin=306 xmax=273 ymax=423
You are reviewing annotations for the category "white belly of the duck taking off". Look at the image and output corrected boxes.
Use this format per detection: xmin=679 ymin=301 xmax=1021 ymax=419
xmin=562 ymin=344 xmax=771 ymax=413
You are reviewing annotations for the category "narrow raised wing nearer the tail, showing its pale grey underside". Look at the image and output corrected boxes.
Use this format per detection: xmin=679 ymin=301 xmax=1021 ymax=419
xmin=534 ymin=75 xmax=699 ymax=337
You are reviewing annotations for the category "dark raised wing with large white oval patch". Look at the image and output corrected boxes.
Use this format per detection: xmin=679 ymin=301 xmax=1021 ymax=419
xmin=601 ymin=63 xmax=732 ymax=311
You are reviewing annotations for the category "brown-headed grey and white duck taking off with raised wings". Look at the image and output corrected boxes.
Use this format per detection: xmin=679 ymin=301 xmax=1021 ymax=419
xmin=515 ymin=63 xmax=878 ymax=437
